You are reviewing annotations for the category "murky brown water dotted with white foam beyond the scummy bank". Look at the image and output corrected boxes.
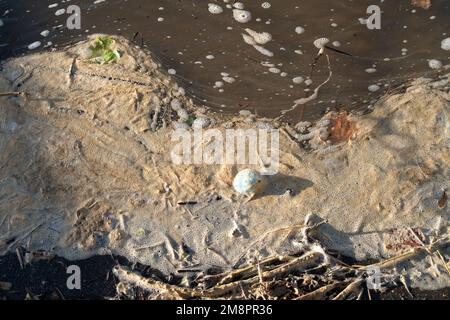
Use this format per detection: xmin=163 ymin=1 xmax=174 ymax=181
xmin=0 ymin=0 xmax=450 ymax=121
